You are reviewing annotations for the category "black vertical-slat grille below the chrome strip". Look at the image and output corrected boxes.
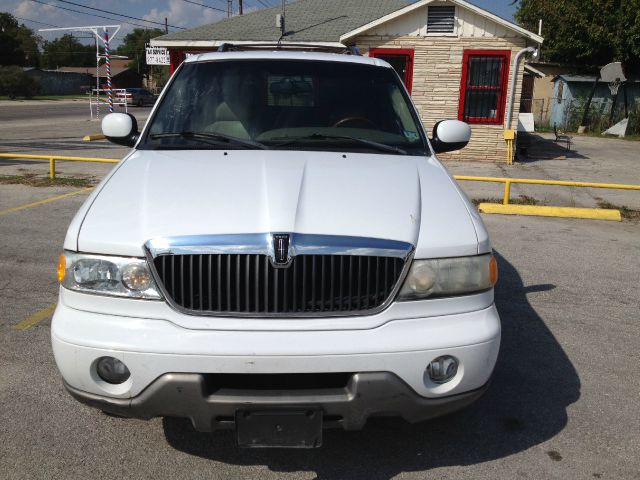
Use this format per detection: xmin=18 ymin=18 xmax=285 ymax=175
xmin=154 ymin=254 xmax=404 ymax=316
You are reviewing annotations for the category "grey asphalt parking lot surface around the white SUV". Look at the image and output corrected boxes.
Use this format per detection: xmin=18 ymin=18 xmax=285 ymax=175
xmin=0 ymin=100 xmax=640 ymax=480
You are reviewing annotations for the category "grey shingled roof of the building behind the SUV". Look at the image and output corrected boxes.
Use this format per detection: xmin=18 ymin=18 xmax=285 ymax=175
xmin=152 ymin=0 xmax=407 ymax=46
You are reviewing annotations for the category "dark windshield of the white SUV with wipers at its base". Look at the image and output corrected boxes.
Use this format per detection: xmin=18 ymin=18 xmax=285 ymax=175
xmin=139 ymin=60 xmax=428 ymax=155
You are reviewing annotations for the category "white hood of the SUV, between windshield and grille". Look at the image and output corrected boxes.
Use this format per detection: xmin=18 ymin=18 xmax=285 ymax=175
xmin=65 ymin=150 xmax=481 ymax=258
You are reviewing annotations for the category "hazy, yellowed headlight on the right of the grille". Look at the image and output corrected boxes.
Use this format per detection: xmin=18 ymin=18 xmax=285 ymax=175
xmin=398 ymin=254 xmax=498 ymax=300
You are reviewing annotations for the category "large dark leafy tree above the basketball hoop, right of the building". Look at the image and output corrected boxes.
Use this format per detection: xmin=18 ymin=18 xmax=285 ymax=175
xmin=515 ymin=0 xmax=640 ymax=73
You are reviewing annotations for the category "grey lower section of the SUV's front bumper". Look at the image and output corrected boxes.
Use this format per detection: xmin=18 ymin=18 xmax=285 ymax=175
xmin=65 ymin=372 xmax=488 ymax=432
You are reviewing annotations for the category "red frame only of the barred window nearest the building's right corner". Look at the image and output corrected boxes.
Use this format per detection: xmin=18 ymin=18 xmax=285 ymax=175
xmin=458 ymin=50 xmax=511 ymax=125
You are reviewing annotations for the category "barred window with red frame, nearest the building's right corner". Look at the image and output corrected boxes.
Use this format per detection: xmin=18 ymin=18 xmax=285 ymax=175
xmin=458 ymin=50 xmax=511 ymax=125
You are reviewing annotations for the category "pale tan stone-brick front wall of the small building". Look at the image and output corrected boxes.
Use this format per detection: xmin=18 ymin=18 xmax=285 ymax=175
xmin=356 ymin=36 xmax=527 ymax=163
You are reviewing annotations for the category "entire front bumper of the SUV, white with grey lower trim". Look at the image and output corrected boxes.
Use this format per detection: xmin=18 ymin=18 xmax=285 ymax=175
xmin=51 ymin=289 xmax=500 ymax=430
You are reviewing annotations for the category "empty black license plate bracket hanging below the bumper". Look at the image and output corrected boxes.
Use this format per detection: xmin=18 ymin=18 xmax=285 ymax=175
xmin=236 ymin=409 xmax=322 ymax=448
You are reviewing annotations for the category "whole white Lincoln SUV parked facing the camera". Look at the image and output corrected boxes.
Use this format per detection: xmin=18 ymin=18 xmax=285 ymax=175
xmin=51 ymin=51 xmax=500 ymax=447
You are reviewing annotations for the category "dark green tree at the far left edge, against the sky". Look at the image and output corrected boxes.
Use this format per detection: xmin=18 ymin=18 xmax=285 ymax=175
xmin=0 ymin=13 xmax=41 ymax=67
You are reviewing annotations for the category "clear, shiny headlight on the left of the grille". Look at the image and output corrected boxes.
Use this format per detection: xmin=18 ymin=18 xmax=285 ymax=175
xmin=58 ymin=252 xmax=162 ymax=299
